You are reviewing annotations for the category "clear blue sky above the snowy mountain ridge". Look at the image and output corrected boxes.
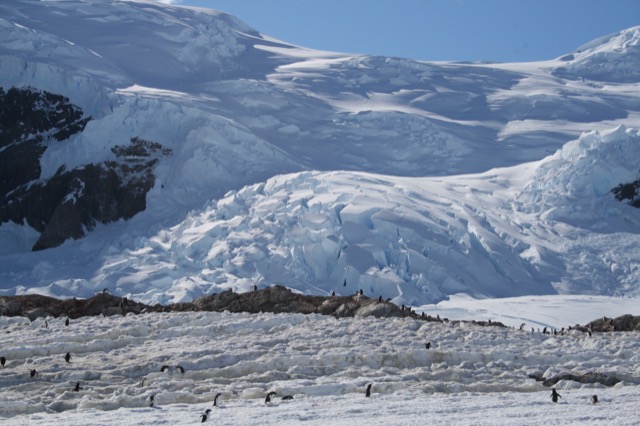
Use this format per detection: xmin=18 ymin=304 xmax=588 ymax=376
xmin=173 ymin=0 xmax=640 ymax=62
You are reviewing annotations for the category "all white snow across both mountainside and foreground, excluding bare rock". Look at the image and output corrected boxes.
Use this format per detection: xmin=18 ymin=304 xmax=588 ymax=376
xmin=0 ymin=0 xmax=640 ymax=426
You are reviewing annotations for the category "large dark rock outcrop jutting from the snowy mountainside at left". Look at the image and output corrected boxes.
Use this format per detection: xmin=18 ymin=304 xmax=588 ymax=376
xmin=0 ymin=88 xmax=171 ymax=250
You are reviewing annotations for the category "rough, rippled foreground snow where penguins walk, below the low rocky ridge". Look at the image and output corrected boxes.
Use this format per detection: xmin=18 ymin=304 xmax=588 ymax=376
xmin=0 ymin=313 xmax=640 ymax=425
